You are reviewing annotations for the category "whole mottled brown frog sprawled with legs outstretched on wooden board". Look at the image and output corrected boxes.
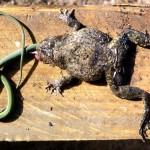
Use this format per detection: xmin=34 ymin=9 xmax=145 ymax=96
xmin=37 ymin=10 xmax=150 ymax=141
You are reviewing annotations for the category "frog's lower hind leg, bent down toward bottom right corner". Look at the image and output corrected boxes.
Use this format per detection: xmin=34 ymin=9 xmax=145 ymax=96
xmin=106 ymin=71 xmax=150 ymax=141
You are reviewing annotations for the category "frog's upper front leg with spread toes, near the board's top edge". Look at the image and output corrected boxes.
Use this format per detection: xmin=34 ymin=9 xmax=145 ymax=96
xmin=59 ymin=9 xmax=84 ymax=30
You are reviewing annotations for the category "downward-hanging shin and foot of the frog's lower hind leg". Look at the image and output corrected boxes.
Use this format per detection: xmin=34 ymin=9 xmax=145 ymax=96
xmin=139 ymin=93 xmax=150 ymax=142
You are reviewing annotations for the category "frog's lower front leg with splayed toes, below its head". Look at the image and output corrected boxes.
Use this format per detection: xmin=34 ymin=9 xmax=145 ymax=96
xmin=45 ymin=76 xmax=73 ymax=94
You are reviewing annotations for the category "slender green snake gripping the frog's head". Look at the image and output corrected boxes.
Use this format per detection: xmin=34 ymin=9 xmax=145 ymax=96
xmin=0 ymin=11 xmax=37 ymax=120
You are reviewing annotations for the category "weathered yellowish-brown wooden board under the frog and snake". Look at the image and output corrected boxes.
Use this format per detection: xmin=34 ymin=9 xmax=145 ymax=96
xmin=0 ymin=6 xmax=150 ymax=141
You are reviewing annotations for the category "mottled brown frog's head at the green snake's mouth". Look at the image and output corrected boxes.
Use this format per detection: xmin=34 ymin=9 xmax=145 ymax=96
xmin=33 ymin=36 xmax=66 ymax=68
